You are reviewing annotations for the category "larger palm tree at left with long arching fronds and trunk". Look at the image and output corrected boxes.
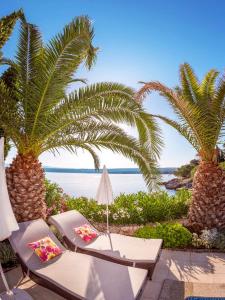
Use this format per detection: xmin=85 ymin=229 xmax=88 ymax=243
xmin=0 ymin=17 xmax=161 ymax=221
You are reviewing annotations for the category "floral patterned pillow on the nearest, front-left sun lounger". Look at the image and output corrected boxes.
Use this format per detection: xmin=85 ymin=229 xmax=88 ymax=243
xmin=27 ymin=237 xmax=62 ymax=262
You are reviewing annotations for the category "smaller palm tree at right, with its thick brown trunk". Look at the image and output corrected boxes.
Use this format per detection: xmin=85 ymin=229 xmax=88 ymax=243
xmin=136 ymin=63 xmax=225 ymax=231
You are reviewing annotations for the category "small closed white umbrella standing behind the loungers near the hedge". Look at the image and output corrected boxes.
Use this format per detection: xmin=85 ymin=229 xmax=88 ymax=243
xmin=96 ymin=166 xmax=113 ymax=232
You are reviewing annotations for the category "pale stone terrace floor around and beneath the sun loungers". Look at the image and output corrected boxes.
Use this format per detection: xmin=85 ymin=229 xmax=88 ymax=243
xmin=0 ymin=250 xmax=225 ymax=300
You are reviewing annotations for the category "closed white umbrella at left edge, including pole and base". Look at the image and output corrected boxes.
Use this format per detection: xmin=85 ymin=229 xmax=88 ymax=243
xmin=0 ymin=138 xmax=32 ymax=300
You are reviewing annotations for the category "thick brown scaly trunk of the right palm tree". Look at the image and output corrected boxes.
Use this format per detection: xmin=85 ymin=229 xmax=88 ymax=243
xmin=188 ymin=162 xmax=225 ymax=232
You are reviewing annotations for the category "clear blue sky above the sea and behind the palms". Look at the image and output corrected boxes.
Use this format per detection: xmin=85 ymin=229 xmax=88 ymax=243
xmin=0 ymin=0 xmax=225 ymax=168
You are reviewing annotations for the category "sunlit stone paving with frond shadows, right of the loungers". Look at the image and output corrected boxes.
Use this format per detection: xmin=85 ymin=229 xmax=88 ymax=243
xmin=142 ymin=250 xmax=225 ymax=300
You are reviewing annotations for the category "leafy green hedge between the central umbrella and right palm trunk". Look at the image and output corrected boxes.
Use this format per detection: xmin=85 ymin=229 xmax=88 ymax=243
xmin=112 ymin=189 xmax=191 ymax=224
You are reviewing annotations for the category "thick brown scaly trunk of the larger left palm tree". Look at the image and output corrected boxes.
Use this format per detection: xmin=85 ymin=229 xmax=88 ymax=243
xmin=6 ymin=154 xmax=46 ymax=222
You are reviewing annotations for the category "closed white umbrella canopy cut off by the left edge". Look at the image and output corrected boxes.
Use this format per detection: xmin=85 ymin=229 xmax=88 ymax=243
xmin=0 ymin=138 xmax=19 ymax=241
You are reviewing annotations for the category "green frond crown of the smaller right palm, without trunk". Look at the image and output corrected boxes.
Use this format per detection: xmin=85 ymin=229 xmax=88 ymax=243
xmin=137 ymin=64 xmax=225 ymax=161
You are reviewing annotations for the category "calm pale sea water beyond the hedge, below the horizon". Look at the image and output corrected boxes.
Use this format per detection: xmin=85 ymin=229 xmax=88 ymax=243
xmin=46 ymin=172 xmax=175 ymax=198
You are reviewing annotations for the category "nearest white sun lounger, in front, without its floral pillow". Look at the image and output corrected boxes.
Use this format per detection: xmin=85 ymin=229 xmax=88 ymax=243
xmin=10 ymin=219 xmax=147 ymax=300
